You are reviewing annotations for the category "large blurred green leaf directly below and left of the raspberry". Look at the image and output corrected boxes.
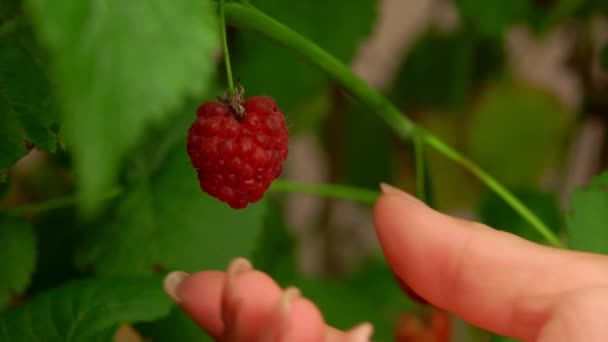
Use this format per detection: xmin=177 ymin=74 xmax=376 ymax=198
xmin=78 ymin=143 xmax=265 ymax=275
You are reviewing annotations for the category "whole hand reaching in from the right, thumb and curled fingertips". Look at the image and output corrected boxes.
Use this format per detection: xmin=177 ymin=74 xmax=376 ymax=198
xmin=164 ymin=185 xmax=608 ymax=342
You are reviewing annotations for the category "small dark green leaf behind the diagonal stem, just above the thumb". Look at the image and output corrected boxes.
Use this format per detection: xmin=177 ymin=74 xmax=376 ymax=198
xmin=478 ymin=189 xmax=562 ymax=242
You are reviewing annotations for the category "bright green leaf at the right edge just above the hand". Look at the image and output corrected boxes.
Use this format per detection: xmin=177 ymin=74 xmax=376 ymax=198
xmin=566 ymin=171 xmax=608 ymax=254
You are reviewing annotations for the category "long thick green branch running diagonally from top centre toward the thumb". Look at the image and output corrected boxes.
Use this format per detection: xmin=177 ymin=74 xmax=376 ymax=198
xmin=220 ymin=3 xmax=563 ymax=247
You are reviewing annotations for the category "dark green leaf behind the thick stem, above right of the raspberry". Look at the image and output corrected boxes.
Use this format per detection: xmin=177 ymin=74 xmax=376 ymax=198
xmin=233 ymin=0 xmax=377 ymax=129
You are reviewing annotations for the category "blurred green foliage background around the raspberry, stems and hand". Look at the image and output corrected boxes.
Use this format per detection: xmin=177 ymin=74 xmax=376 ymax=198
xmin=0 ymin=0 xmax=608 ymax=342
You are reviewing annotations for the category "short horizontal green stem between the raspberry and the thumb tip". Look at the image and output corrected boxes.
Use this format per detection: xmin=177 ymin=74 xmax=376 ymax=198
xmin=270 ymin=179 xmax=380 ymax=205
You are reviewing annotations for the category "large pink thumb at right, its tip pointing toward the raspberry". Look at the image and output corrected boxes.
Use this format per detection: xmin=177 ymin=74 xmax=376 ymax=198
xmin=374 ymin=188 xmax=608 ymax=339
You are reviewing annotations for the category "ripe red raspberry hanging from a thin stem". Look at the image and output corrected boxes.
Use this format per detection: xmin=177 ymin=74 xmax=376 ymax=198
xmin=187 ymin=92 xmax=289 ymax=209
